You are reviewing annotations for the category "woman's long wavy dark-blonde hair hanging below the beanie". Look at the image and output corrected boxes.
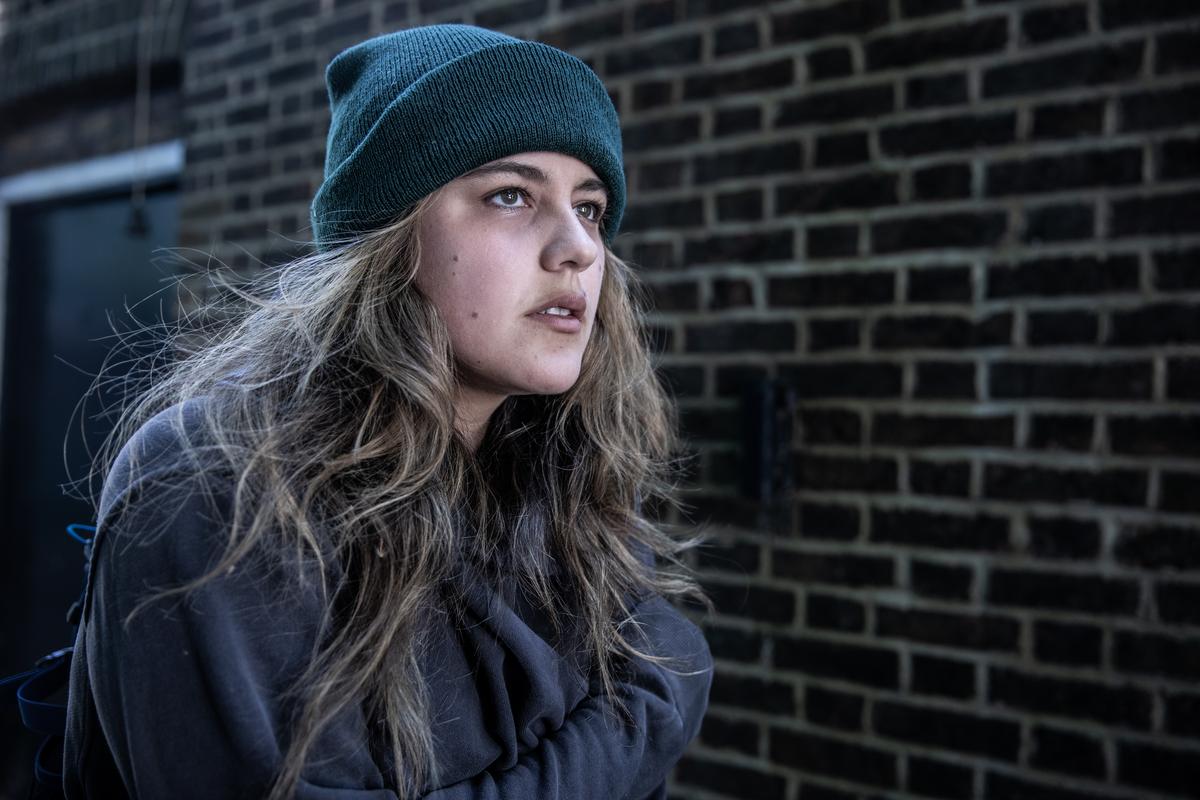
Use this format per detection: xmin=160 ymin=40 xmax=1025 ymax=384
xmin=95 ymin=196 xmax=707 ymax=800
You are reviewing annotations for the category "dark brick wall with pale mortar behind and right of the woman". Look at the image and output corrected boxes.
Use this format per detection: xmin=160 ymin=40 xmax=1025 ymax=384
xmin=2 ymin=0 xmax=1200 ymax=800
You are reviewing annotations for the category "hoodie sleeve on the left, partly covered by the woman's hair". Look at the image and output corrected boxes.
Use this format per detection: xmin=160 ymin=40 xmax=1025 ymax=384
xmin=83 ymin=474 xmax=396 ymax=800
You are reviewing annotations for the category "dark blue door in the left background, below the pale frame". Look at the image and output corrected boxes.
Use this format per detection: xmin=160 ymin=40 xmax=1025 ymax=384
xmin=0 ymin=178 xmax=179 ymax=771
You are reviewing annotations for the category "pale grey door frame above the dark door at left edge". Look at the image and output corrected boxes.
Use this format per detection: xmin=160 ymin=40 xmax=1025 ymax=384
xmin=0 ymin=139 xmax=184 ymax=422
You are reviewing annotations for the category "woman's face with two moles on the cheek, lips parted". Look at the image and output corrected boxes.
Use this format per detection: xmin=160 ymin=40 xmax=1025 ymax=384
xmin=415 ymin=152 xmax=607 ymax=411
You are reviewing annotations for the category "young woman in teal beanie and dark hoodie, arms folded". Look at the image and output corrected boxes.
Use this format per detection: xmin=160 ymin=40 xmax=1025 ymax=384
xmin=65 ymin=25 xmax=712 ymax=800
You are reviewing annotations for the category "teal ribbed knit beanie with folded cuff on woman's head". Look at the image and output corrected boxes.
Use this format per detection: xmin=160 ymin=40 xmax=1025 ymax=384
xmin=311 ymin=25 xmax=625 ymax=249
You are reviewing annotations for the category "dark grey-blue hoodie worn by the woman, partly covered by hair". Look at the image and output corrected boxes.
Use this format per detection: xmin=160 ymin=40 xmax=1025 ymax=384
xmin=64 ymin=407 xmax=712 ymax=800
